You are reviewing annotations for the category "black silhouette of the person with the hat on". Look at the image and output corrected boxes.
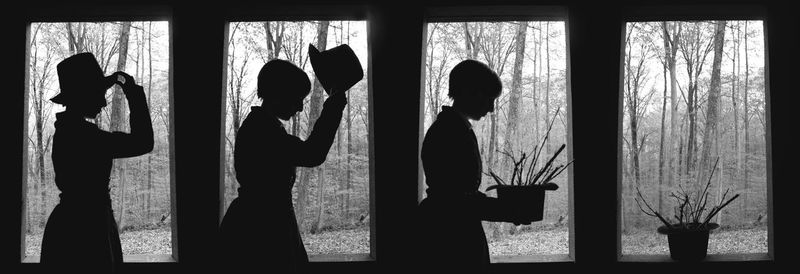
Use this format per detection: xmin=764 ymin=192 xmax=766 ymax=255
xmin=41 ymin=53 xmax=153 ymax=273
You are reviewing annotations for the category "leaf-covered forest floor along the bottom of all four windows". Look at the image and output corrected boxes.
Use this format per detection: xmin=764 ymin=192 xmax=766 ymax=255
xmin=26 ymin=228 xmax=767 ymax=256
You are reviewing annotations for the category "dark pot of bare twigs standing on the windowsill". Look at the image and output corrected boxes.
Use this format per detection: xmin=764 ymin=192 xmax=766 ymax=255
xmin=635 ymin=158 xmax=739 ymax=261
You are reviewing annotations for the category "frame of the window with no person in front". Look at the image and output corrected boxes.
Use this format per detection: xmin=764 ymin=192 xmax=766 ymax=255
xmin=615 ymin=4 xmax=775 ymax=263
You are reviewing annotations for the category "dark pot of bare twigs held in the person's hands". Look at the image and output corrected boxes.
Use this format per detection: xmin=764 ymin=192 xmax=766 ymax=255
xmin=486 ymin=109 xmax=572 ymax=221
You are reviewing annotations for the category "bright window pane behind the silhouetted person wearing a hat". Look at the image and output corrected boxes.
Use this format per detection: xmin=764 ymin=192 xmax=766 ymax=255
xmin=24 ymin=21 xmax=172 ymax=256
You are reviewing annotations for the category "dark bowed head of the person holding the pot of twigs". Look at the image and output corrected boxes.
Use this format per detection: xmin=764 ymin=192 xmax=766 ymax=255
xmin=447 ymin=60 xmax=503 ymax=120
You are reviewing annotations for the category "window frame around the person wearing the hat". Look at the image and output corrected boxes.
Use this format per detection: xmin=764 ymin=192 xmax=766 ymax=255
xmin=19 ymin=3 xmax=179 ymax=265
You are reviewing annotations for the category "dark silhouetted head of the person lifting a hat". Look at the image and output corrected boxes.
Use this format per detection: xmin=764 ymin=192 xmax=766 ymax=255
xmin=258 ymin=59 xmax=311 ymax=120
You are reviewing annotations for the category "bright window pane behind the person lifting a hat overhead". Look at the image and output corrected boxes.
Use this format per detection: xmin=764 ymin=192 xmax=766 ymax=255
xmin=224 ymin=21 xmax=370 ymax=255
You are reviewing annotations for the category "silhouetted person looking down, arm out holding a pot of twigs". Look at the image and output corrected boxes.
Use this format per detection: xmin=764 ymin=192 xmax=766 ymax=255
xmin=418 ymin=60 xmax=530 ymax=273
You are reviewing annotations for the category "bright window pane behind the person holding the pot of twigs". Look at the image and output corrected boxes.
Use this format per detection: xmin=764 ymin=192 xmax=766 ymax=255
xmin=421 ymin=21 xmax=570 ymax=255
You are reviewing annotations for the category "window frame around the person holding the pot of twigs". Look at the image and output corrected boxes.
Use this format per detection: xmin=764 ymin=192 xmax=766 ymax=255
xmin=417 ymin=5 xmax=575 ymax=264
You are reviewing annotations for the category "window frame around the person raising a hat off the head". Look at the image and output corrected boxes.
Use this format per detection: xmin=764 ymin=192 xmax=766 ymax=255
xmin=219 ymin=4 xmax=377 ymax=264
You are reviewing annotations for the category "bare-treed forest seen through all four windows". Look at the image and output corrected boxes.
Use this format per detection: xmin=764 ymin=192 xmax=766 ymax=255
xmin=23 ymin=18 xmax=769 ymax=255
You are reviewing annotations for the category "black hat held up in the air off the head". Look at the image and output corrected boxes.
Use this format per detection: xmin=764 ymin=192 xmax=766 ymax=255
xmin=308 ymin=44 xmax=364 ymax=93
